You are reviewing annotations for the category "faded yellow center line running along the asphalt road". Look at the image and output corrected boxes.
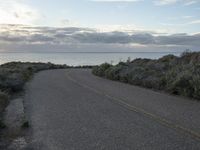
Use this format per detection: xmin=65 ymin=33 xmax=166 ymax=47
xmin=66 ymin=73 xmax=200 ymax=141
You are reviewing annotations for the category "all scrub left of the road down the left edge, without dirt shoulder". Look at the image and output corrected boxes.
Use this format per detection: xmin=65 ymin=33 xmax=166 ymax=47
xmin=0 ymin=62 xmax=68 ymax=128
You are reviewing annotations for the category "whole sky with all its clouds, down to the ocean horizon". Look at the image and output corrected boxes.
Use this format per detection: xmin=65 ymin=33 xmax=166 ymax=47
xmin=0 ymin=0 xmax=200 ymax=51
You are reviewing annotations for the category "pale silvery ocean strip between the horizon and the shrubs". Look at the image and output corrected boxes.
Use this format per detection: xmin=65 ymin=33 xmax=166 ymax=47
xmin=0 ymin=52 xmax=180 ymax=66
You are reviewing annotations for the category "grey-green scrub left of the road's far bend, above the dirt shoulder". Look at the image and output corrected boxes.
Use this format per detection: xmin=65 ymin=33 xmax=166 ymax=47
xmin=0 ymin=62 xmax=68 ymax=92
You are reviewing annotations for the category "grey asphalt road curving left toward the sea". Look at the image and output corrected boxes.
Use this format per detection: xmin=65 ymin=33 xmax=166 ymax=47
xmin=25 ymin=69 xmax=200 ymax=150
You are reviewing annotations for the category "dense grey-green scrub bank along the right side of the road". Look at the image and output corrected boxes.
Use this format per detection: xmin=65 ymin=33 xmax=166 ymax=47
xmin=92 ymin=51 xmax=200 ymax=100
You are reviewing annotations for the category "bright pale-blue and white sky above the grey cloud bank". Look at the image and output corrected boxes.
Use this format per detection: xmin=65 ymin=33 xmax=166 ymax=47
xmin=0 ymin=0 xmax=200 ymax=34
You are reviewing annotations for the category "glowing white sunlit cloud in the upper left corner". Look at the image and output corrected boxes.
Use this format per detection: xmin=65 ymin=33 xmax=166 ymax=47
xmin=0 ymin=0 xmax=40 ymax=24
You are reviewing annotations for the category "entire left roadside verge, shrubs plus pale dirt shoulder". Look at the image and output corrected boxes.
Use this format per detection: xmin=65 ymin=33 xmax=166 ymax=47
xmin=0 ymin=62 xmax=68 ymax=149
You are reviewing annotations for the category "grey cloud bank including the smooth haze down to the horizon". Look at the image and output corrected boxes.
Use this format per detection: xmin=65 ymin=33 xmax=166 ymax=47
xmin=0 ymin=25 xmax=200 ymax=52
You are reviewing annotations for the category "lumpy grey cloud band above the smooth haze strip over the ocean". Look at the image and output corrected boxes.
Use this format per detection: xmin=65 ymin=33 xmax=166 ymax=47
xmin=0 ymin=25 xmax=200 ymax=47
